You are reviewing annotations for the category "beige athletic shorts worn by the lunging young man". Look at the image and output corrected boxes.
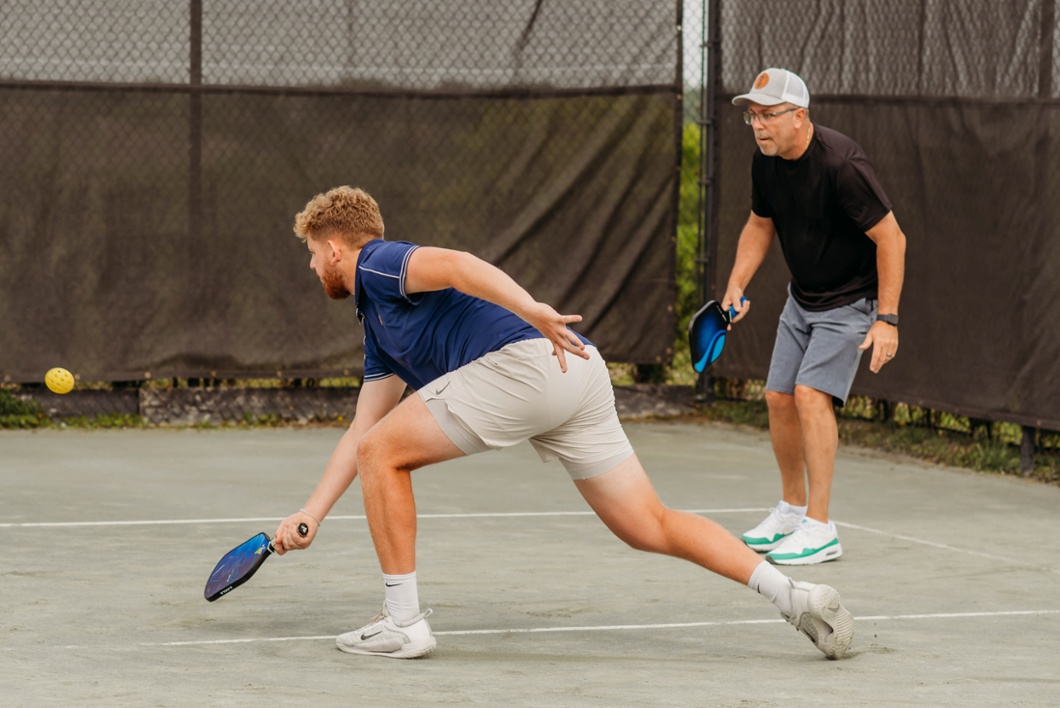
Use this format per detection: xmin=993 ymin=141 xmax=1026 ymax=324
xmin=417 ymin=338 xmax=633 ymax=479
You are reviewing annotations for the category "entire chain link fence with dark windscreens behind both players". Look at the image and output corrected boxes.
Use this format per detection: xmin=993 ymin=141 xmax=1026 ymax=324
xmin=6 ymin=0 xmax=1060 ymax=481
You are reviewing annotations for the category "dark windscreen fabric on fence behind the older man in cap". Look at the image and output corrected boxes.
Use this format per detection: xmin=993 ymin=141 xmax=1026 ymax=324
xmin=714 ymin=0 xmax=1060 ymax=429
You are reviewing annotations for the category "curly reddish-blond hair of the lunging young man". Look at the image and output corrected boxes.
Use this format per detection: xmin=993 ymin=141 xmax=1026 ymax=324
xmin=295 ymin=187 xmax=383 ymax=247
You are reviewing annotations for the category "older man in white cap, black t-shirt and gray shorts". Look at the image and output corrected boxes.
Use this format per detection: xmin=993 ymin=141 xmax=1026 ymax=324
xmin=722 ymin=69 xmax=905 ymax=565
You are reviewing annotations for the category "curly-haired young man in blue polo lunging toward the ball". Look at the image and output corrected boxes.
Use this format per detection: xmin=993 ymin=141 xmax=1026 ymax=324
xmin=276 ymin=187 xmax=853 ymax=658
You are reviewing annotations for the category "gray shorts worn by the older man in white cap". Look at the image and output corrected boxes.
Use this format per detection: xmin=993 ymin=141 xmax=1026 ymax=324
xmin=765 ymin=293 xmax=876 ymax=406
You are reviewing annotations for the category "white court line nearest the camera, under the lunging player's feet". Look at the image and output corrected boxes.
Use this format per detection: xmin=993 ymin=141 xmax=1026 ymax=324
xmin=33 ymin=609 xmax=1060 ymax=651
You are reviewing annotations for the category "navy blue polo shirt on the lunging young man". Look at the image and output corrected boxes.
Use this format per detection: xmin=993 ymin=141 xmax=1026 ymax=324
xmin=355 ymin=238 xmax=591 ymax=389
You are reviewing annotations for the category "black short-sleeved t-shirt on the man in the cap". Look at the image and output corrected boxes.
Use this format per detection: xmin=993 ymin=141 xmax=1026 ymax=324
xmin=750 ymin=125 xmax=890 ymax=312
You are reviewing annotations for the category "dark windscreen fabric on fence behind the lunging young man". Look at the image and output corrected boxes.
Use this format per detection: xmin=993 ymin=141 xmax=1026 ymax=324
xmin=0 ymin=0 xmax=681 ymax=382
